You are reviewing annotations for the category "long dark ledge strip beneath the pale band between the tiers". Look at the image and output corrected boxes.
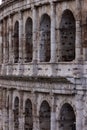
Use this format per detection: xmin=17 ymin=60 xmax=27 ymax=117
xmin=0 ymin=75 xmax=72 ymax=84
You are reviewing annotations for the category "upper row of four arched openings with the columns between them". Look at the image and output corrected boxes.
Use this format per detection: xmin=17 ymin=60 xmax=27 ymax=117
xmin=1 ymin=9 xmax=76 ymax=63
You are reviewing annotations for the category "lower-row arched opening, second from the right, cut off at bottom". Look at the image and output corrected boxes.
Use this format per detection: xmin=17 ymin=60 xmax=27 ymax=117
xmin=39 ymin=101 xmax=51 ymax=130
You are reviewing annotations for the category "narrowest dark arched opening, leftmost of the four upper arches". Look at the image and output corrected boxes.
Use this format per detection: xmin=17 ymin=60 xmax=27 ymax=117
xmin=13 ymin=21 xmax=19 ymax=63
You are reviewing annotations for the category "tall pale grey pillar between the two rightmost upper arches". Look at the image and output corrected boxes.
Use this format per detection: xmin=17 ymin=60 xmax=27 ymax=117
xmin=51 ymin=2 xmax=56 ymax=63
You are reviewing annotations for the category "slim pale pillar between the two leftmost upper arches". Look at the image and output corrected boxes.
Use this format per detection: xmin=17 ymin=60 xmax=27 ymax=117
xmin=19 ymin=11 xmax=23 ymax=63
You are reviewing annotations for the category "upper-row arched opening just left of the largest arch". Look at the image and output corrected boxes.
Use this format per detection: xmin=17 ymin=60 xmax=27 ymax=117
xmin=40 ymin=14 xmax=51 ymax=62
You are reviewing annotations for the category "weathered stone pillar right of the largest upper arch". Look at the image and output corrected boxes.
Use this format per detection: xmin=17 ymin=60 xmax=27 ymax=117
xmin=76 ymin=0 xmax=82 ymax=61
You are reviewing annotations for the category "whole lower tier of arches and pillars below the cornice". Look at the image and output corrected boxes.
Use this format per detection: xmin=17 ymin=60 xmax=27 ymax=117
xmin=0 ymin=88 xmax=86 ymax=130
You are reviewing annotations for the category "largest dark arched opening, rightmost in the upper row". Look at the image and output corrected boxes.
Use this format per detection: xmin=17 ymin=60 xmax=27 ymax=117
xmin=60 ymin=9 xmax=76 ymax=62
